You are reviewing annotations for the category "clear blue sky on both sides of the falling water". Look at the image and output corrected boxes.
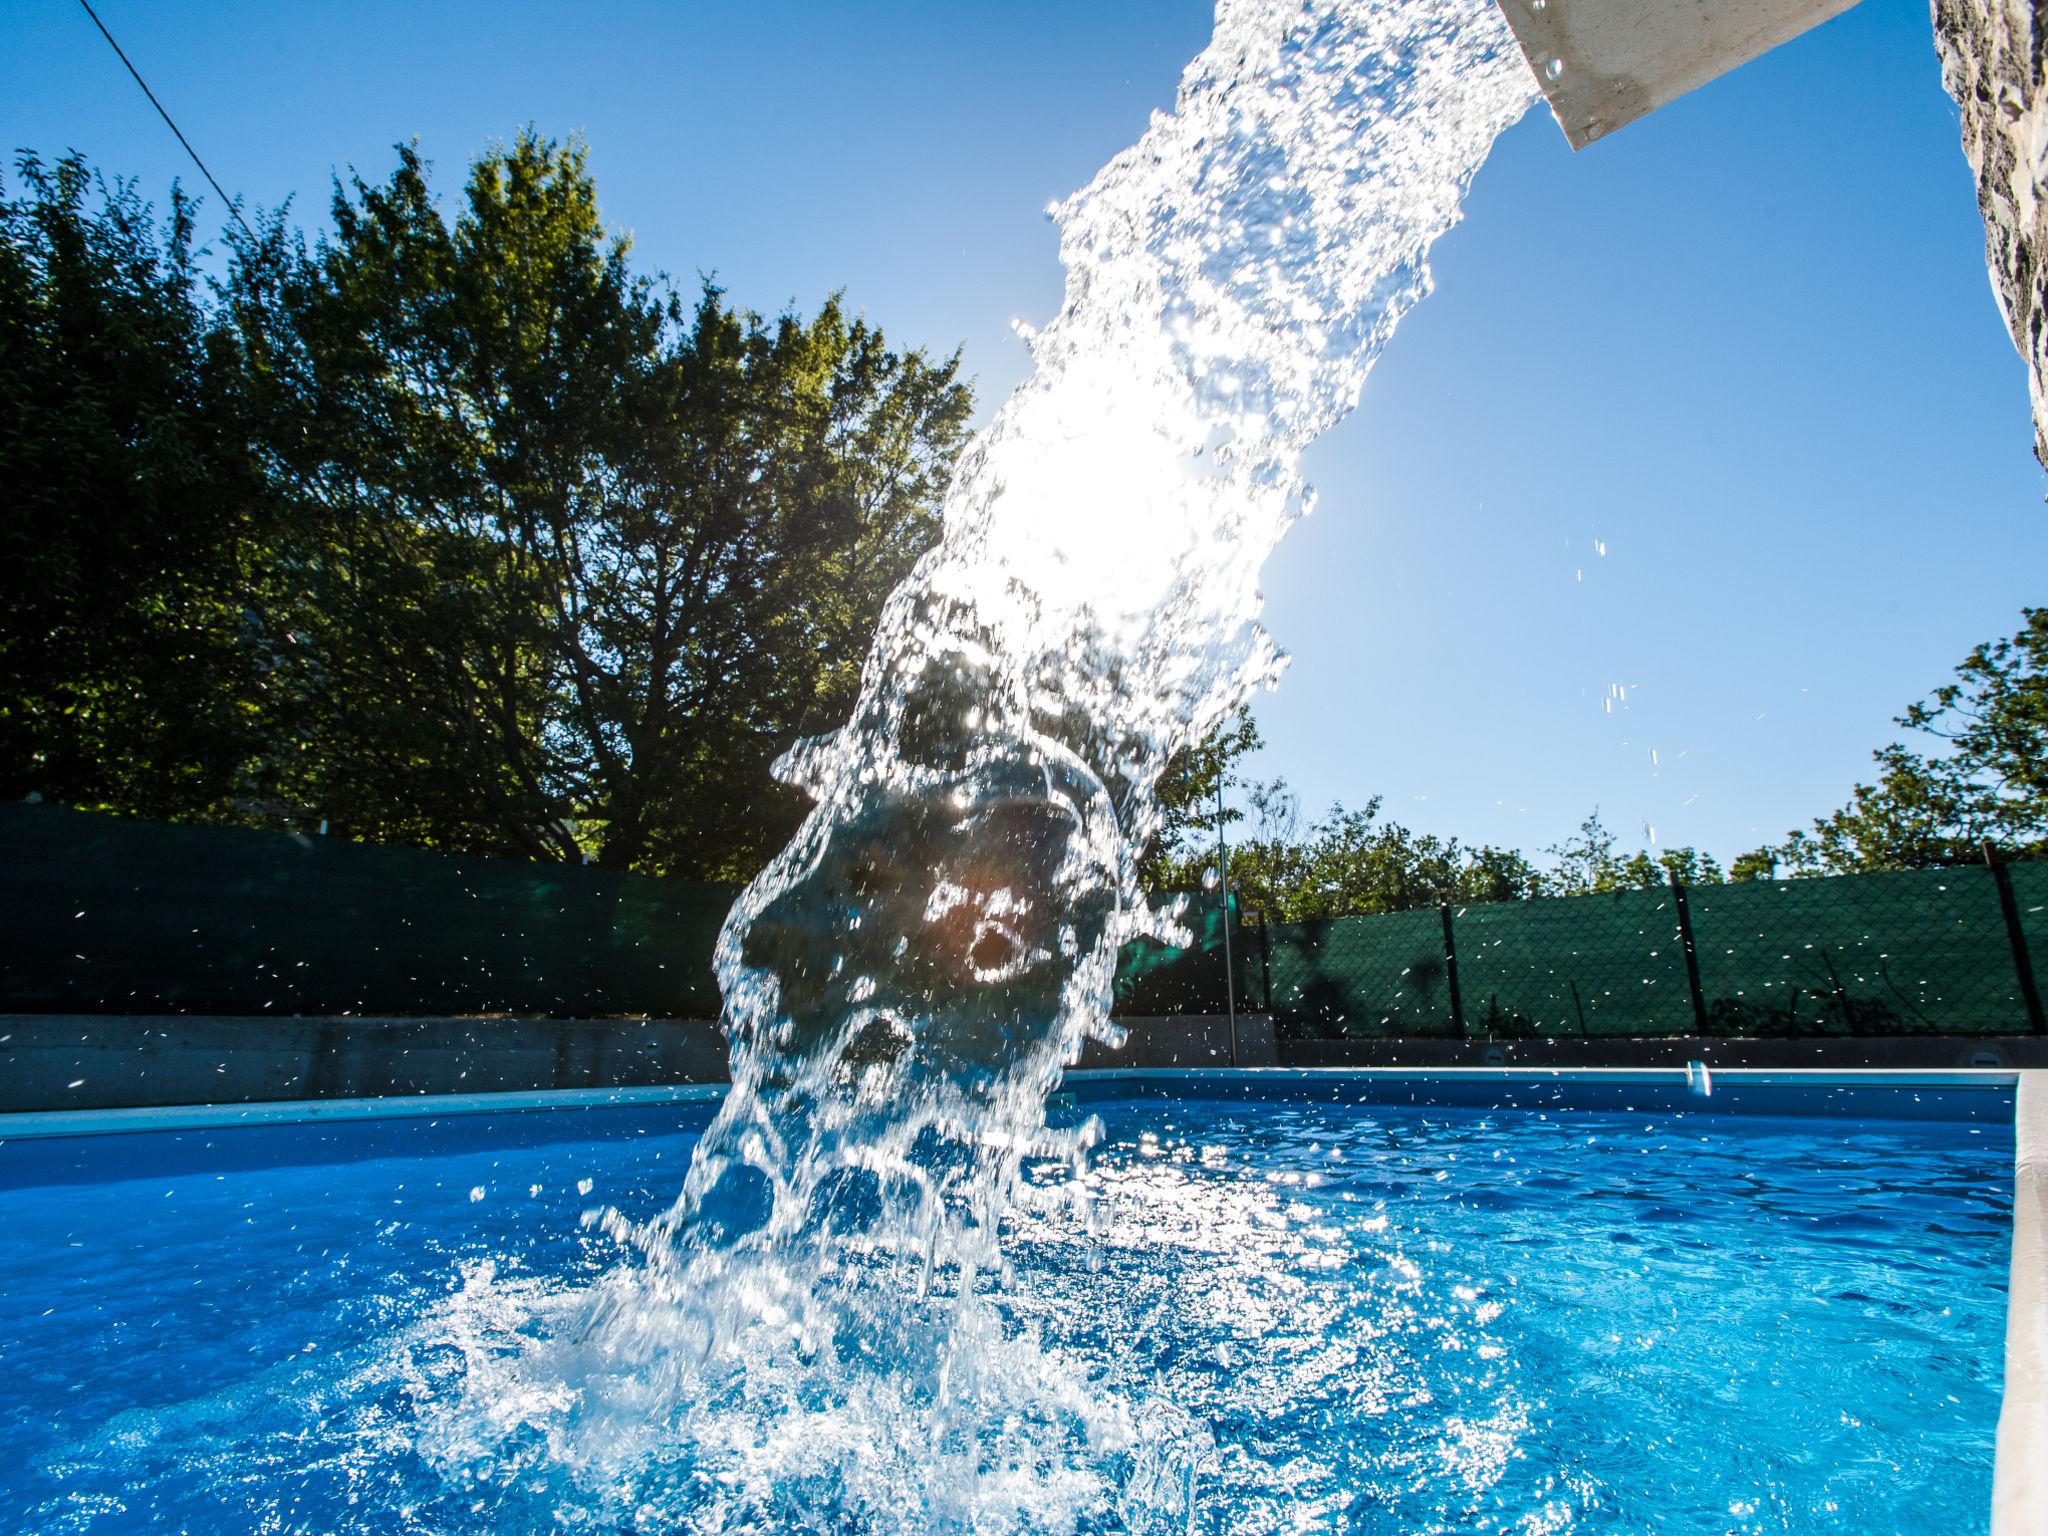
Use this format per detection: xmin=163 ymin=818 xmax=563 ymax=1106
xmin=0 ymin=0 xmax=2048 ymax=856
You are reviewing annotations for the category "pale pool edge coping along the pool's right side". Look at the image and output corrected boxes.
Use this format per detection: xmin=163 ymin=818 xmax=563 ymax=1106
xmin=1991 ymin=1067 xmax=2048 ymax=1536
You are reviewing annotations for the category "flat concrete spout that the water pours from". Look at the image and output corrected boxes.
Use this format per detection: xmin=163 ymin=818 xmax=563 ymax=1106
xmin=1501 ymin=0 xmax=1855 ymax=150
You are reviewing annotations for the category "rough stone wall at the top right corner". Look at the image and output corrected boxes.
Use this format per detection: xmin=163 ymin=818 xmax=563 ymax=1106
xmin=1933 ymin=0 xmax=2048 ymax=465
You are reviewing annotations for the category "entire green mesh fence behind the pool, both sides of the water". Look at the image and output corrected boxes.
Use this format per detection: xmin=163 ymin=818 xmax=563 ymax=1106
xmin=0 ymin=805 xmax=2048 ymax=1038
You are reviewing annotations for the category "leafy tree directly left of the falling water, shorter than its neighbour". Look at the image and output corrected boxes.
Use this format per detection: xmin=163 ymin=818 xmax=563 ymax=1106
xmin=569 ymin=287 xmax=971 ymax=877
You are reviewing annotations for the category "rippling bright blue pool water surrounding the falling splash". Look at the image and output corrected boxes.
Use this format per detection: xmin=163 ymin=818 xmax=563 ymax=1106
xmin=0 ymin=1083 xmax=2013 ymax=1536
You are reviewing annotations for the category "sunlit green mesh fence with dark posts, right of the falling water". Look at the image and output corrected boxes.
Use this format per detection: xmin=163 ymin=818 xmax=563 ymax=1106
xmin=1264 ymin=862 xmax=2048 ymax=1038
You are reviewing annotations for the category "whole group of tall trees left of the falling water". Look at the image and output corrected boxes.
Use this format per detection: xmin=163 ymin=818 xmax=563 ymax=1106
xmin=0 ymin=133 xmax=971 ymax=877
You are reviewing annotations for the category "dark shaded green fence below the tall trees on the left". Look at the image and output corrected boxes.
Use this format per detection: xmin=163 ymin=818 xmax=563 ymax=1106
xmin=0 ymin=805 xmax=733 ymax=1018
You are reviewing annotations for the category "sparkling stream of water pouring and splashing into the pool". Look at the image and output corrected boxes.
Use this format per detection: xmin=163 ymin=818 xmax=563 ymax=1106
xmin=430 ymin=0 xmax=1534 ymax=1530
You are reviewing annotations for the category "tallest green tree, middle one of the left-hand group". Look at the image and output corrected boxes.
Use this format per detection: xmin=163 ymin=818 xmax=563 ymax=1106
xmin=240 ymin=137 xmax=626 ymax=858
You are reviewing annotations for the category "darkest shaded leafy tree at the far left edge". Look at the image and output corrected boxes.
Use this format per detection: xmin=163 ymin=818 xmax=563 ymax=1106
xmin=0 ymin=156 xmax=274 ymax=819
